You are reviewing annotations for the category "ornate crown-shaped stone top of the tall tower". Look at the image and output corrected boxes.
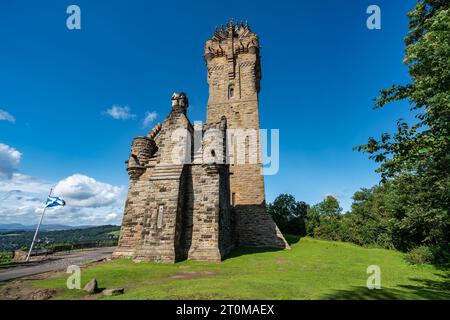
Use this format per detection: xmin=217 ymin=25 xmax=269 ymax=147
xmin=204 ymin=19 xmax=259 ymax=62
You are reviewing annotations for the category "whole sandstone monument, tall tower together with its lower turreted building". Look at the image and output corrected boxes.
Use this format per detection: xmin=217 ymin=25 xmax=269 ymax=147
xmin=113 ymin=21 xmax=289 ymax=263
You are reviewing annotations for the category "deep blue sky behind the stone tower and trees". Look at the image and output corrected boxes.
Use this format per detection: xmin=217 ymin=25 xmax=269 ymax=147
xmin=0 ymin=0 xmax=415 ymax=225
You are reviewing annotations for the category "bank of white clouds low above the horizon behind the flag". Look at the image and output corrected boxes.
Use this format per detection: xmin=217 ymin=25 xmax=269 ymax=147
xmin=0 ymin=161 xmax=126 ymax=226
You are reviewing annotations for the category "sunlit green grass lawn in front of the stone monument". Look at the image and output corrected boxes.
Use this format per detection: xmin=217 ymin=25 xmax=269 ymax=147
xmin=29 ymin=238 xmax=450 ymax=299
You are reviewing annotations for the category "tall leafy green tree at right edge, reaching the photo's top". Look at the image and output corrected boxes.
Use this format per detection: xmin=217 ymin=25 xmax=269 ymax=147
xmin=355 ymin=0 xmax=450 ymax=259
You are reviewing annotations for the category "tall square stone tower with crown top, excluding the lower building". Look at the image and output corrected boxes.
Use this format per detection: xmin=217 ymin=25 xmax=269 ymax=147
xmin=204 ymin=20 xmax=288 ymax=248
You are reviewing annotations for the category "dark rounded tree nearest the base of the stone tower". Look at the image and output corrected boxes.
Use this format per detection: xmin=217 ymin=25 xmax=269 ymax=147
xmin=267 ymin=194 xmax=308 ymax=236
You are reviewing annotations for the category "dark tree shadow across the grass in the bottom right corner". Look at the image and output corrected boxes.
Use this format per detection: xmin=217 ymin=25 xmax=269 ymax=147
xmin=323 ymin=274 xmax=450 ymax=300
